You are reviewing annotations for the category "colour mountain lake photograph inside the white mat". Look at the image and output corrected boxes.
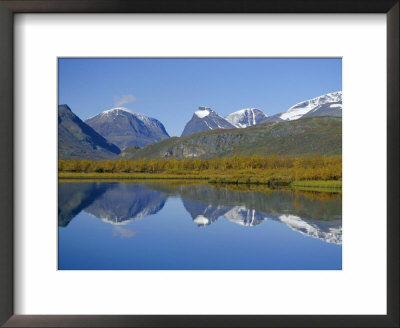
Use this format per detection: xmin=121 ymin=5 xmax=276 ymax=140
xmin=58 ymin=58 xmax=342 ymax=274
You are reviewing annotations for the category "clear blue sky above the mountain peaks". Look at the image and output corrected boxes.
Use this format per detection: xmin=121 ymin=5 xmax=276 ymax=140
xmin=58 ymin=58 xmax=342 ymax=136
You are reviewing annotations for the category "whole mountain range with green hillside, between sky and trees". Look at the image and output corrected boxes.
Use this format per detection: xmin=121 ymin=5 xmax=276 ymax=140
xmin=58 ymin=91 xmax=342 ymax=160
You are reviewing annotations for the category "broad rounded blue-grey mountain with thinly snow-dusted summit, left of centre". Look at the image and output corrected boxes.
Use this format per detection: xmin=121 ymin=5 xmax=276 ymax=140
xmin=85 ymin=107 xmax=169 ymax=149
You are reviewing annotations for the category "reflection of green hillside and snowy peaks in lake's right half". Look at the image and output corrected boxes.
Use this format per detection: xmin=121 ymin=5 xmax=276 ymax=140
xmin=151 ymin=184 xmax=342 ymax=244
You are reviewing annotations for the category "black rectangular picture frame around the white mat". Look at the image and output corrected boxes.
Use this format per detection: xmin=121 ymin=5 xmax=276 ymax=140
xmin=0 ymin=0 xmax=400 ymax=327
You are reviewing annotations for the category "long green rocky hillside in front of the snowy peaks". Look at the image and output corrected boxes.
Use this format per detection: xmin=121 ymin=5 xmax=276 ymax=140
xmin=121 ymin=117 xmax=342 ymax=159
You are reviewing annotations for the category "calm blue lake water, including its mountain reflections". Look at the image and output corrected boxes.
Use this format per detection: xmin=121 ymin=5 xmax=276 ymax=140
xmin=58 ymin=182 xmax=342 ymax=270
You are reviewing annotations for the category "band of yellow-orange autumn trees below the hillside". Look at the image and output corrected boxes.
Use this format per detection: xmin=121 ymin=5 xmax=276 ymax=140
xmin=58 ymin=155 xmax=342 ymax=180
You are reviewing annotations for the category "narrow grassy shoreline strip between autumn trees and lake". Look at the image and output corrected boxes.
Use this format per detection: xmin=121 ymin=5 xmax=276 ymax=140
xmin=58 ymin=172 xmax=342 ymax=192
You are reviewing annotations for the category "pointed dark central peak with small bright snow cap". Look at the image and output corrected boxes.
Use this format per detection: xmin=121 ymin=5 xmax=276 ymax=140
xmin=181 ymin=106 xmax=235 ymax=137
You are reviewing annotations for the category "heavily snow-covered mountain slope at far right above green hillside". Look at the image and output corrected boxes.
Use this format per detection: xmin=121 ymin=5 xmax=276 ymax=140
xmin=279 ymin=91 xmax=342 ymax=121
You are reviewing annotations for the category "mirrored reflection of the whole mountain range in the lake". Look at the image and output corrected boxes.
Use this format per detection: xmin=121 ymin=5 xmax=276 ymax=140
xmin=58 ymin=182 xmax=342 ymax=244
